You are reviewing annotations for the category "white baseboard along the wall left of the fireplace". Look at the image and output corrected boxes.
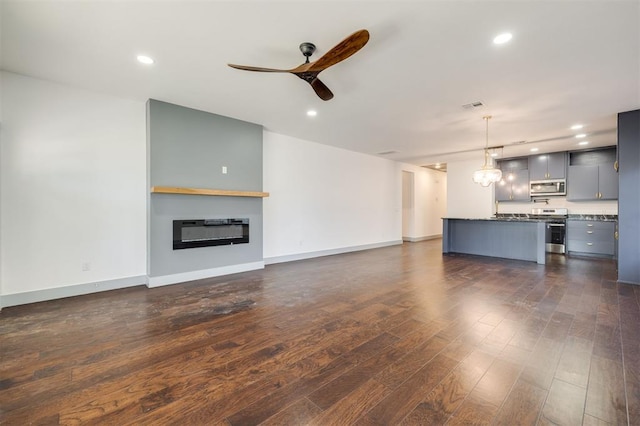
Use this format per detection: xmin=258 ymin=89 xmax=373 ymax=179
xmin=0 ymin=275 xmax=147 ymax=309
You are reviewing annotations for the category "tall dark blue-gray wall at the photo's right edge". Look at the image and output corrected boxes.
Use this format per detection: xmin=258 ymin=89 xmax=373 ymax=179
xmin=618 ymin=110 xmax=640 ymax=284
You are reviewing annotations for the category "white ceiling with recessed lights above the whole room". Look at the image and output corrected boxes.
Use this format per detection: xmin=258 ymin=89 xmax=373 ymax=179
xmin=0 ymin=0 xmax=640 ymax=165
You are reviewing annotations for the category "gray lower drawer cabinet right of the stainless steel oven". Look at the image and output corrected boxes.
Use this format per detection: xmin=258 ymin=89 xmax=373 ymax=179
xmin=566 ymin=220 xmax=616 ymax=257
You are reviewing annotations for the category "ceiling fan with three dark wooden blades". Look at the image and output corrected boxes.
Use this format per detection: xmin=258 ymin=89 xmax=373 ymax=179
xmin=227 ymin=30 xmax=369 ymax=101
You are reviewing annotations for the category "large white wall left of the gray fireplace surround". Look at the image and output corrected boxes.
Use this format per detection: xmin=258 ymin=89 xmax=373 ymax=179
xmin=0 ymin=72 xmax=148 ymax=300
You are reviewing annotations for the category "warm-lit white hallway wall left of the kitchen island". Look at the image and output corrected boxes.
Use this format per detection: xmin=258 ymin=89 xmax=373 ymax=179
xmin=400 ymin=163 xmax=448 ymax=241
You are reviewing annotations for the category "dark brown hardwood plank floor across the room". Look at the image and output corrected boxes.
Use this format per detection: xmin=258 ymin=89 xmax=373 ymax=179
xmin=0 ymin=240 xmax=640 ymax=425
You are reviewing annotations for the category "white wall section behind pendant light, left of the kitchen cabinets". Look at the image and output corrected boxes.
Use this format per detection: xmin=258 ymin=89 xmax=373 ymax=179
xmin=446 ymin=159 xmax=495 ymax=219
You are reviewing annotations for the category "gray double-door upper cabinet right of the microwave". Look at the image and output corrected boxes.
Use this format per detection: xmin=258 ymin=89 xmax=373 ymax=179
xmin=567 ymin=147 xmax=618 ymax=201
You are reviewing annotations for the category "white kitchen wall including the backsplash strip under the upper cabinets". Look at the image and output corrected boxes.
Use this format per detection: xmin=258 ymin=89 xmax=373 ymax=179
xmin=447 ymin=156 xmax=618 ymax=218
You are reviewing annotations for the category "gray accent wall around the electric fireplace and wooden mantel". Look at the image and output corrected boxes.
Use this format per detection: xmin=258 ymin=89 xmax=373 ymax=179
xmin=147 ymin=99 xmax=263 ymax=277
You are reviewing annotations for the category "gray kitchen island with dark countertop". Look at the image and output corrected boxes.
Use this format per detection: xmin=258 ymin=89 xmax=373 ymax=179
xmin=442 ymin=218 xmax=545 ymax=265
